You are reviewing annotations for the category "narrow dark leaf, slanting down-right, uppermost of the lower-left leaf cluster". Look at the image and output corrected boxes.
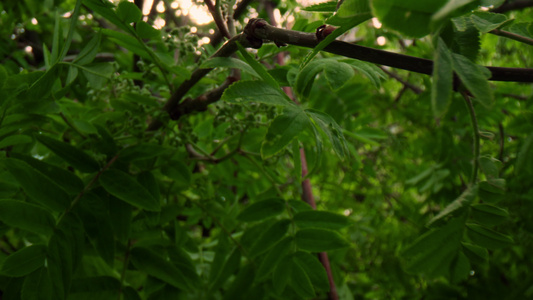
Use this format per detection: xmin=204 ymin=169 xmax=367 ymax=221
xmin=35 ymin=135 xmax=100 ymax=173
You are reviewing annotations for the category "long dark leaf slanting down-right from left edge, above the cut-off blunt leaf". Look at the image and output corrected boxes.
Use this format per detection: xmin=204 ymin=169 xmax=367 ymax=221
xmin=3 ymin=158 xmax=70 ymax=211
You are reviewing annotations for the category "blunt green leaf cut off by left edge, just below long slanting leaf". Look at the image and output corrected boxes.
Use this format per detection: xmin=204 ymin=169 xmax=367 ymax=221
xmin=0 ymin=200 xmax=55 ymax=236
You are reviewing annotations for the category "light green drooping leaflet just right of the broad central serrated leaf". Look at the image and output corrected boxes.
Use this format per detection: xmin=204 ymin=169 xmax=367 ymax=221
xmin=305 ymin=109 xmax=348 ymax=159
